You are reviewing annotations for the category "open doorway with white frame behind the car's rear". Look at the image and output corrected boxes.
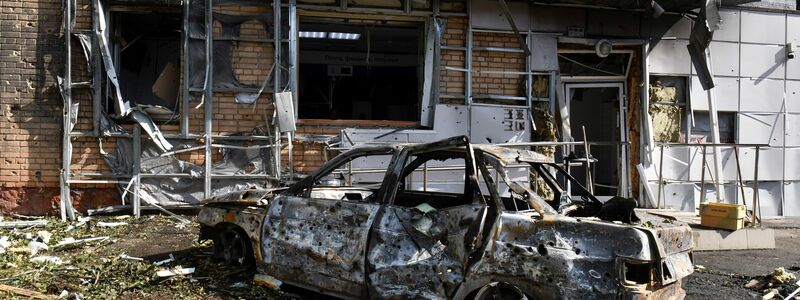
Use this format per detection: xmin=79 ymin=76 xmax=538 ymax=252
xmin=565 ymin=82 xmax=629 ymax=197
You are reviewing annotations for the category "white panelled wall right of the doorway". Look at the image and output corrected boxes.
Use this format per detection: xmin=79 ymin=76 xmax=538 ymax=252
xmin=648 ymin=8 xmax=800 ymax=216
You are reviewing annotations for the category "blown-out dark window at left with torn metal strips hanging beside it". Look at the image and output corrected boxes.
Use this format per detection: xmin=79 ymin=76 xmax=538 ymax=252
xmin=111 ymin=11 xmax=182 ymax=120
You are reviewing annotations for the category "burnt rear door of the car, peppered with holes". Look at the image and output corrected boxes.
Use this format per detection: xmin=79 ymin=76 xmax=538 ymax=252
xmin=367 ymin=147 xmax=488 ymax=299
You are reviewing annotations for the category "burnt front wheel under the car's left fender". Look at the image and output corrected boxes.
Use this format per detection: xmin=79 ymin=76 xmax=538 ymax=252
xmin=214 ymin=226 xmax=253 ymax=266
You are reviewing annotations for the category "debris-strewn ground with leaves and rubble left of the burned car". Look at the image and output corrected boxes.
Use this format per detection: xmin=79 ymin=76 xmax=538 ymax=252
xmin=0 ymin=216 xmax=288 ymax=299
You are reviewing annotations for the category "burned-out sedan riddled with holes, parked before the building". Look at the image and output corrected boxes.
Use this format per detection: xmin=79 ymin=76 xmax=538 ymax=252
xmin=198 ymin=137 xmax=693 ymax=299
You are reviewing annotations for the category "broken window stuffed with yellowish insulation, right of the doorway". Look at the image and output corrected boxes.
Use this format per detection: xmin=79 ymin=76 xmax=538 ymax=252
xmin=649 ymin=76 xmax=687 ymax=143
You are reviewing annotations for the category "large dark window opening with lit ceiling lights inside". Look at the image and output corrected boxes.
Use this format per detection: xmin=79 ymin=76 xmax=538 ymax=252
xmin=298 ymin=18 xmax=424 ymax=121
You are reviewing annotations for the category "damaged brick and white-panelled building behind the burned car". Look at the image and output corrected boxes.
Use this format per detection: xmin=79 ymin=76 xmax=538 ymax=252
xmin=0 ymin=0 xmax=800 ymax=219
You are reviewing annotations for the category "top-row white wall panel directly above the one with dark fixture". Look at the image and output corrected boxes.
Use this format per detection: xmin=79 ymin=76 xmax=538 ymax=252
xmin=741 ymin=10 xmax=786 ymax=44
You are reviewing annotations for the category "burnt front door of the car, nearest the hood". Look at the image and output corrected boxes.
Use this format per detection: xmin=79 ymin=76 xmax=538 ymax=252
xmin=262 ymin=150 xmax=392 ymax=298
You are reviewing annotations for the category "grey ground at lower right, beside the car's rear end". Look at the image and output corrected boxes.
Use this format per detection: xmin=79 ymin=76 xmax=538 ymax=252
xmin=684 ymin=218 xmax=800 ymax=299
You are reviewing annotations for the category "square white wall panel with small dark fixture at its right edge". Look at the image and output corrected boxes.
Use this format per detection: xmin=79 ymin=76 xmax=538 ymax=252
xmin=740 ymin=44 xmax=786 ymax=79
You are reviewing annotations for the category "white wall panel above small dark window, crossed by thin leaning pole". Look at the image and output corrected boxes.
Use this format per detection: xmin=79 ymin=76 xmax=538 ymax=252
xmin=691 ymin=76 xmax=739 ymax=111
